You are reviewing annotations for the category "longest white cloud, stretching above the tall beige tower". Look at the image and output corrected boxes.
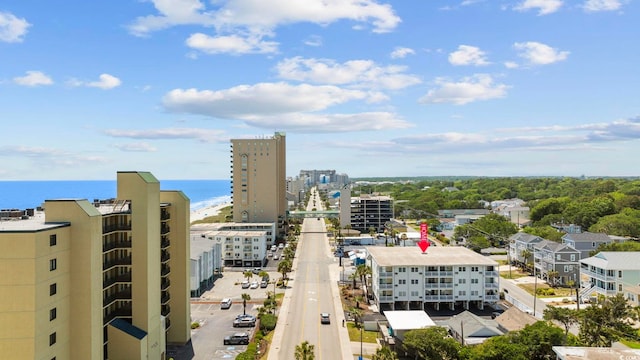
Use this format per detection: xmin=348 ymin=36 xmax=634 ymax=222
xmin=162 ymin=82 xmax=368 ymax=120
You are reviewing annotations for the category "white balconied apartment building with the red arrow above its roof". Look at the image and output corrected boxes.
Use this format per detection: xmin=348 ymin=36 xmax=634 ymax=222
xmin=366 ymin=246 xmax=500 ymax=312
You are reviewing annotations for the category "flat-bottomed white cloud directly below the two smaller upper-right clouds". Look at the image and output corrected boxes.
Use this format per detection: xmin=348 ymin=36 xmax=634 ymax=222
xmin=419 ymin=74 xmax=509 ymax=105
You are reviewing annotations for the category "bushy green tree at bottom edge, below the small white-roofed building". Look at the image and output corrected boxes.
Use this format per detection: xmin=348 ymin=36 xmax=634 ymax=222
xmin=402 ymin=326 xmax=461 ymax=360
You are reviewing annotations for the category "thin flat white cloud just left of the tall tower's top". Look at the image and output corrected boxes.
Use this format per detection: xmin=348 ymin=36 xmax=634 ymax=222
xmin=102 ymin=128 xmax=229 ymax=143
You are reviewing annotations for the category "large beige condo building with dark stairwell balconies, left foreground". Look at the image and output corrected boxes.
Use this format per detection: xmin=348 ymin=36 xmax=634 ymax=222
xmin=0 ymin=172 xmax=190 ymax=360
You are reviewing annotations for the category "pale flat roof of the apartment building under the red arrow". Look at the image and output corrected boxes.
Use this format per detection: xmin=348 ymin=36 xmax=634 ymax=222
xmin=365 ymin=246 xmax=498 ymax=266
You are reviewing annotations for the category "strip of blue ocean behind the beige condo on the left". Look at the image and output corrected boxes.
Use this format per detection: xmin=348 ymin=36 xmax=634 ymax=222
xmin=0 ymin=179 xmax=231 ymax=211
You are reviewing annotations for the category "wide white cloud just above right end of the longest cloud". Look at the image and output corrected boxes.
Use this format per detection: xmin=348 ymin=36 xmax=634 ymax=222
xmin=276 ymin=56 xmax=421 ymax=90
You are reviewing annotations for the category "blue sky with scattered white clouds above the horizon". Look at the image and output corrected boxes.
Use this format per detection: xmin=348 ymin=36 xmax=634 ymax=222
xmin=0 ymin=0 xmax=640 ymax=180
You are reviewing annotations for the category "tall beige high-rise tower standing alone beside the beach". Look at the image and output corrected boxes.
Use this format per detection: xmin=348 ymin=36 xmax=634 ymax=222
xmin=231 ymin=132 xmax=287 ymax=237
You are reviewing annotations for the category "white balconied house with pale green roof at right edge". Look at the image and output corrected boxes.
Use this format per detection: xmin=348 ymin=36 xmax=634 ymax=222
xmin=580 ymin=251 xmax=640 ymax=306
